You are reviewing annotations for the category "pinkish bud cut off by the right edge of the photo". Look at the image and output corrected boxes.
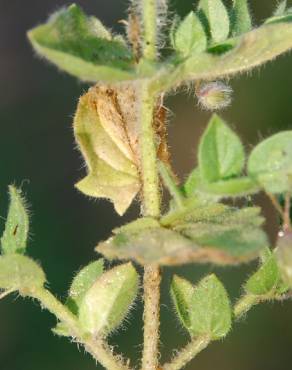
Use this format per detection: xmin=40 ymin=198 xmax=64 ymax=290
xmin=276 ymin=231 xmax=292 ymax=287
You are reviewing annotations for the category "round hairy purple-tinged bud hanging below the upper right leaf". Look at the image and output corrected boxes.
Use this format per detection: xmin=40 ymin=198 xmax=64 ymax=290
xmin=196 ymin=81 xmax=233 ymax=110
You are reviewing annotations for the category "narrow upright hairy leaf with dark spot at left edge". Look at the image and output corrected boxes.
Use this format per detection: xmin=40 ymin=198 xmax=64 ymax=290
xmin=1 ymin=185 xmax=29 ymax=254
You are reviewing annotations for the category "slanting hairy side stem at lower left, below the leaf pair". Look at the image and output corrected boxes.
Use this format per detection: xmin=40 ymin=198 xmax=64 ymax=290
xmin=26 ymin=288 xmax=130 ymax=370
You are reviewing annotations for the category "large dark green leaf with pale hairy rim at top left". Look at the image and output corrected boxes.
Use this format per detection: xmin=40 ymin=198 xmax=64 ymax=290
xmin=28 ymin=4 xmax=133 ymax=82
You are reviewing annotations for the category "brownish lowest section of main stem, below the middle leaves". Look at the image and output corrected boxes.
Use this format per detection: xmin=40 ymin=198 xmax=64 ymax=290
xmin=142 ymin=265 xmax=161 ymax=370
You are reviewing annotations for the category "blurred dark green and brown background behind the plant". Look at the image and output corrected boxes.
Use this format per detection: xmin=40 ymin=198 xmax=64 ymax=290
xmin=0 ymin=0 xmax=292 ymax=370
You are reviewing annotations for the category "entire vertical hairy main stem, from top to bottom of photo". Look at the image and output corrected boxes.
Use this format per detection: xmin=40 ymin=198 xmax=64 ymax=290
xmin=139 ymin=0 xmax=161 ymax=370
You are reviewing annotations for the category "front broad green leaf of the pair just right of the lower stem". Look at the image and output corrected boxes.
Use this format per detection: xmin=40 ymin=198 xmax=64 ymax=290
xmin=190 ymin=274 xmax=232 ymax=340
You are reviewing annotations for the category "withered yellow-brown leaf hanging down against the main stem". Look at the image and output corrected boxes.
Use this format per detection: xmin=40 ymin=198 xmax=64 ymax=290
xmin=74 ymin=86 xmax=140 ymax=215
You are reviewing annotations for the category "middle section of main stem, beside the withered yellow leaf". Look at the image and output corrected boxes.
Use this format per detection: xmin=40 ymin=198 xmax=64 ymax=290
xmin=139 ymin=83 xmax=160 ymax=217
